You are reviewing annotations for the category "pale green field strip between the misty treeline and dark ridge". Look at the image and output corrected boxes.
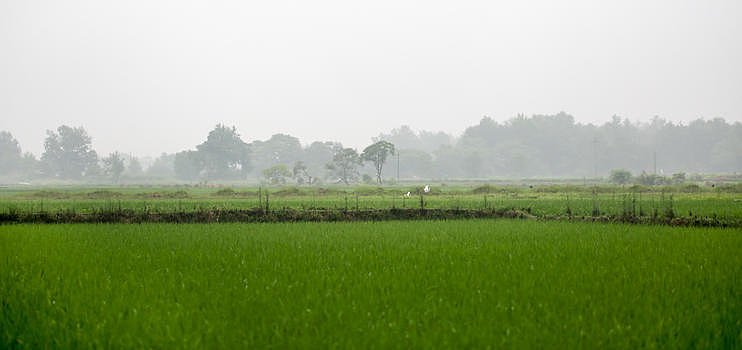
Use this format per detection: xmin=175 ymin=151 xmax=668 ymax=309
xmin=0 ymin=184 xmax=742 ymax=222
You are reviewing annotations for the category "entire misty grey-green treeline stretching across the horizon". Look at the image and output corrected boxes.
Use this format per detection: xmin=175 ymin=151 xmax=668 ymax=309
xmin=0 ymin=113 xmax=742 ymax=184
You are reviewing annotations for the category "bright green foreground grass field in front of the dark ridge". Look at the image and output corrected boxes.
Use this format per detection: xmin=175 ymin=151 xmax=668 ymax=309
xmin=0 ymin=220 xmax=742 ymax=349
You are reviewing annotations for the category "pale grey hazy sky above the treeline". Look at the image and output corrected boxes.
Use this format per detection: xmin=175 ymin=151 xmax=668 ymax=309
xmin=0 ymin=0 xmax=742 ymax=155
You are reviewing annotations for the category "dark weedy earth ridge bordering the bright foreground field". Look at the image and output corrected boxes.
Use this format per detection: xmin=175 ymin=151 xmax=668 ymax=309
xmin=0 ymin=208 xmax=742 ymax=228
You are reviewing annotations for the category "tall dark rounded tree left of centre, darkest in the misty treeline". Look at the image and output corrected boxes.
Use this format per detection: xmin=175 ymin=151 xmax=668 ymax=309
xmin=196 ymin=124 xmax=248 ymax=179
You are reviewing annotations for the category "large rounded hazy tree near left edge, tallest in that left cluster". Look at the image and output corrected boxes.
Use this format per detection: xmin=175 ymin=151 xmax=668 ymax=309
xmin=41 ymin=125 xmax=98 ymax=179
